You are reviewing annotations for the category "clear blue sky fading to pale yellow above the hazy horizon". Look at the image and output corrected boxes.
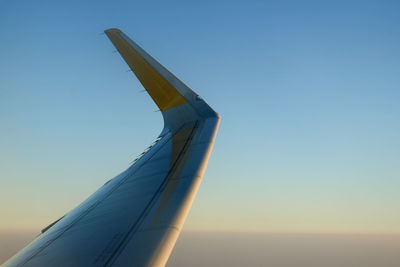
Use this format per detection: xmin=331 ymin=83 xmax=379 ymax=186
xmin=0 ymin=0 xmax=400 ymax=233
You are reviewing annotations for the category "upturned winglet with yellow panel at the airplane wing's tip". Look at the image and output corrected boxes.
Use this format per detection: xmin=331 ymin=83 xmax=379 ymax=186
xmin=104 ymin=28 xmax=219 ymax=129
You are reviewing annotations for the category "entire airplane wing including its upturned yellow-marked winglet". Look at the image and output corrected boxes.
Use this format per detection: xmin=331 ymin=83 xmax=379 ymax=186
xmin=3 ymin=29 xmax=220 ymax=267
